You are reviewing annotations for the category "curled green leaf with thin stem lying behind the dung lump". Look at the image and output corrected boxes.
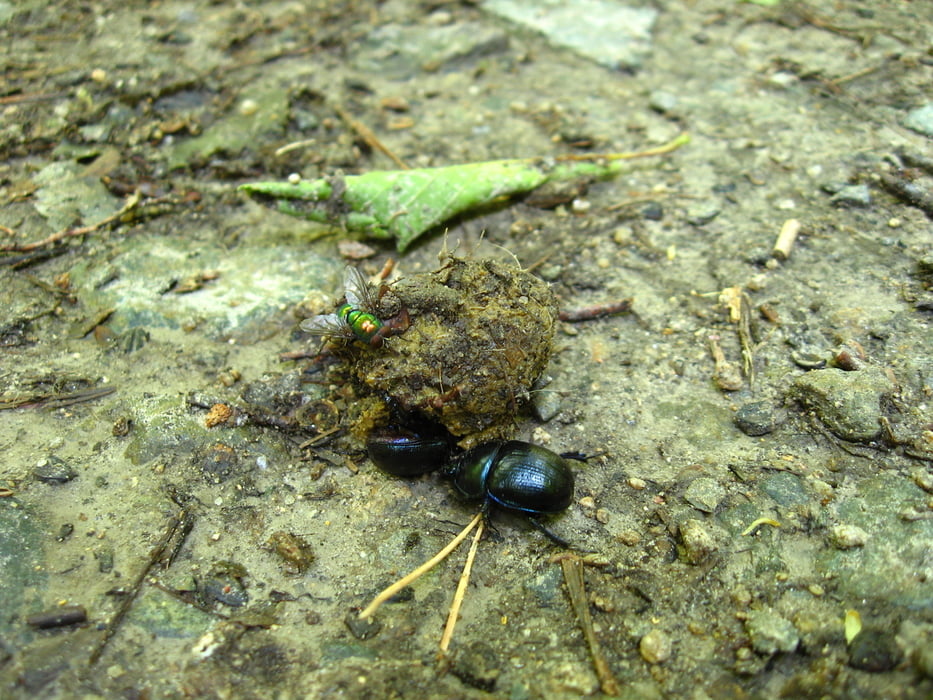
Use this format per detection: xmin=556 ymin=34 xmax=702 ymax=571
xmin=240 ymin=135 xmax=689 ymax=253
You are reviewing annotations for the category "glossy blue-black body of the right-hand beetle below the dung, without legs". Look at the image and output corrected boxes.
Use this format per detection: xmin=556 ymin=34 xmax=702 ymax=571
xmin=447 ymin=440 xmax=573 ymax=515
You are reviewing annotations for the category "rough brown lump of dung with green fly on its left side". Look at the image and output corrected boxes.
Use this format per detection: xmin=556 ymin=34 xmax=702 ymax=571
xmin=347 ymin=257 xmax=557 ymax=447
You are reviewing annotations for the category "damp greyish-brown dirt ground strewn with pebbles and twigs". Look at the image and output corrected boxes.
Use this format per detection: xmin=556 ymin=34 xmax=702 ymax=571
xmin=0 ymin=0 xmax=933 ymax=699
